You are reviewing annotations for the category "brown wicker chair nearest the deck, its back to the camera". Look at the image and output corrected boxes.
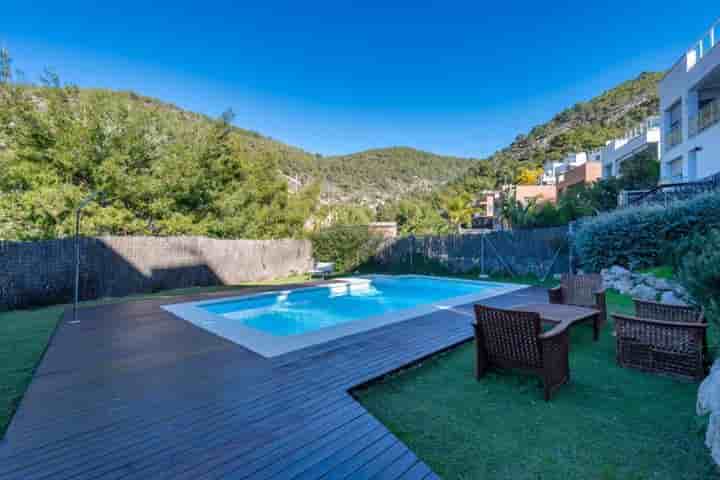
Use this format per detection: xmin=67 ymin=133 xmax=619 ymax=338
xmin=473 ymin=305 xmax=570 ymax=401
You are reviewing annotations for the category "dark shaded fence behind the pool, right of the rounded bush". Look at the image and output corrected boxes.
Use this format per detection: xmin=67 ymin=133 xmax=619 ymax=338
xmin=375 ymin=227 xmax=570 ymax=277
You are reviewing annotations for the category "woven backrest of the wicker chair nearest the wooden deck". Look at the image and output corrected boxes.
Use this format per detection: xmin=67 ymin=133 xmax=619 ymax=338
xmin=475 ymin=305 xmax=542 ymax=368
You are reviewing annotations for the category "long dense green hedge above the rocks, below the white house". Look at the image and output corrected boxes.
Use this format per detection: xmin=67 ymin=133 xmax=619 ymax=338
xmin=575 ymin=193 xmax=720 ymax=272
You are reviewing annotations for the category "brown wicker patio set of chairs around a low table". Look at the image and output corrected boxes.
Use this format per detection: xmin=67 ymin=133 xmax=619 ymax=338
xmin=473 ymin=274 xmax=707 ymax=401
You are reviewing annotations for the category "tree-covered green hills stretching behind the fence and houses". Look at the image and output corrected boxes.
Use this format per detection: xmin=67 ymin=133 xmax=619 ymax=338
xmin=0 ymin=45 xmax=660 ymax=240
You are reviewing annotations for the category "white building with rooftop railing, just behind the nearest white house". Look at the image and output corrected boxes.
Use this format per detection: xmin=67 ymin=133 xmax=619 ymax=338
xmin=599 ymin=117 xmax=661 ymax=178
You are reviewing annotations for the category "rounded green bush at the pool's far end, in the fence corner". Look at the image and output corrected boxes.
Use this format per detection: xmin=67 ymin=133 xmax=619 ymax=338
xmin=311 ymin=226 xmax=382 ymax=272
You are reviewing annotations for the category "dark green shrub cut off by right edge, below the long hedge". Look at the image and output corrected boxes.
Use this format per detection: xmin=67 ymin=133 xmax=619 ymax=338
xmin=678 ymin=230 xmax=720 ymax=321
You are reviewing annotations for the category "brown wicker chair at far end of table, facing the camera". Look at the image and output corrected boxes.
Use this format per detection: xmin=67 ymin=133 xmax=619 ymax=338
xmin=548 ymin=273 xmax=607 ymax=340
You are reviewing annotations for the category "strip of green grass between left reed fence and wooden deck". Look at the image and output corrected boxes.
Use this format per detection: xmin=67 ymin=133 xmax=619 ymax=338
xmin=0 ymin=276 xmax=308 ymax=438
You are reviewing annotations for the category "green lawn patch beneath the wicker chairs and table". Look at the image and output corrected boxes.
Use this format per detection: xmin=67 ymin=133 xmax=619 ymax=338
xmin=355 ymin=292 xmax=717 ymax=480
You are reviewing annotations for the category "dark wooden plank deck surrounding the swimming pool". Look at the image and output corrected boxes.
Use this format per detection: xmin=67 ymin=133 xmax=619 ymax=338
xmin=0 ymin=287 xmax=546 ymax=480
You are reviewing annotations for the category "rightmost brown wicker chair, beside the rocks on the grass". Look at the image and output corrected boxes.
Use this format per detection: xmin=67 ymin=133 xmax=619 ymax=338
xmin=613 ymin=299 xmax=707 ymax=380
